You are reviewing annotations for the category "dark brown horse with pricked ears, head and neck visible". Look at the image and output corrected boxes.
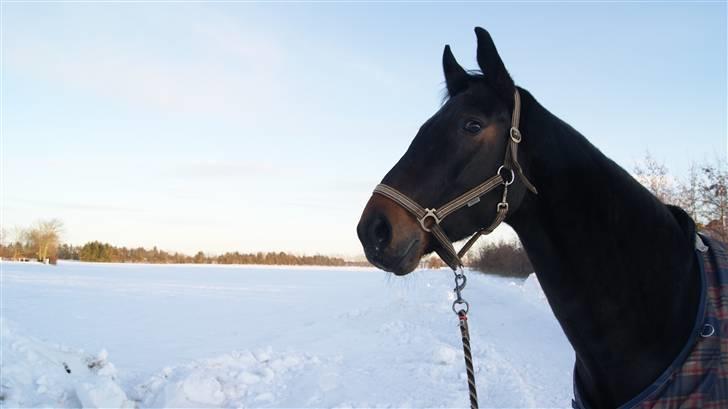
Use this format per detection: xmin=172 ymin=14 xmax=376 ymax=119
xmin=357 ymin=27 xmax=728 ymax=407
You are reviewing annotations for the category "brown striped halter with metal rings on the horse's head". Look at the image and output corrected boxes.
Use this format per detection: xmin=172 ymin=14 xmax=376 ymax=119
xmin=374 ymin=88 xmax=538 ymax=270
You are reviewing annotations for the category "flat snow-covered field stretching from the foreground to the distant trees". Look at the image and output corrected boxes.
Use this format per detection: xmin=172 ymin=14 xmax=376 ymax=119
xmin=0 ymin=262 xmax=573 ymax=408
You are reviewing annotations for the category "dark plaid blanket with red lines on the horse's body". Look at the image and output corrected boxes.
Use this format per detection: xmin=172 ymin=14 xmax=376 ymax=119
xmin=572 ymin=236 xmax=728 ymax=409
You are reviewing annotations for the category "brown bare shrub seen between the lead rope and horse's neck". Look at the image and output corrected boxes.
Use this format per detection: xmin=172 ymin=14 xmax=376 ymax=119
xmin=468 ymin=241 xmax=533 ymax=278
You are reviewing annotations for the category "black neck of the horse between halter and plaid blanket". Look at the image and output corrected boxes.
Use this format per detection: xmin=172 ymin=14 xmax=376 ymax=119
xmin=508 ymin=91 xmax=700 ymax=406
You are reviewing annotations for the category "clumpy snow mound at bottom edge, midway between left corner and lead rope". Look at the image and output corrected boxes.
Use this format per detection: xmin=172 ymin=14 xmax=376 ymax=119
xmin=135 ymin=347 xmax=326 ymax=408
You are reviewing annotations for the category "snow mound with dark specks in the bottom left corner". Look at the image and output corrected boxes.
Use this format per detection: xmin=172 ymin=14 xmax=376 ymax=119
xmin=0 ymin=318 xmax=134 ymax=408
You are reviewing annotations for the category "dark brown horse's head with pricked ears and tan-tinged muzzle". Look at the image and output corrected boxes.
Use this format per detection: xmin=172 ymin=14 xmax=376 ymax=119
xmin=357 ymin=27 xmax=526 ymax=275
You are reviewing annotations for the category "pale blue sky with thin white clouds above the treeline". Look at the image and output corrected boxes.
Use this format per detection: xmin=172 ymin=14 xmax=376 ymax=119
xmin=0 ymin=2 xmax=728 ymax=257
